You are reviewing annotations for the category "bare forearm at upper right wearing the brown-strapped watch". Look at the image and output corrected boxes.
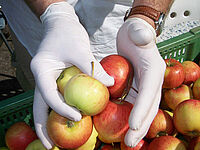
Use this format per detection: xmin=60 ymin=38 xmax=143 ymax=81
xmin=130 ymin=0 xmax=174 ymax=28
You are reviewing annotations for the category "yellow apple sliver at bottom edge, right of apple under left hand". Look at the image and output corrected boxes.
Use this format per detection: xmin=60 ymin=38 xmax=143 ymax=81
xmin=75 ymin=125 xmax=98 ymax=150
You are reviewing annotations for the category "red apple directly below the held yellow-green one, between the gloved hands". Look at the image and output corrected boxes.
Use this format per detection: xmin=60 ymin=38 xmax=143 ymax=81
xmin=93 ymin=100 xmax=133 ymax=143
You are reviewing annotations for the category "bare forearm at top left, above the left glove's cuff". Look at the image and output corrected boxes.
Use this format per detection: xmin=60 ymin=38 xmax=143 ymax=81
xmin=24 ymin=0 xmax=64 ymax=18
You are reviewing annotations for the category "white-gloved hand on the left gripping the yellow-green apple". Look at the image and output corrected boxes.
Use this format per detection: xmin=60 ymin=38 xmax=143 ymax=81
xmin=31 ymin=2 xmax=114 ymax=149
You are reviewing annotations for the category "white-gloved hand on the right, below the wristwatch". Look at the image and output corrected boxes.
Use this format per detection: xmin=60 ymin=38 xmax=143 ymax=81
xmin=117 ymin=18 xmax=166 ymax=147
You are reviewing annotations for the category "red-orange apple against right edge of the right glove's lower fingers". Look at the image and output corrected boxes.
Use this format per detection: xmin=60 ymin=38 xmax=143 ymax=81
xmin=145 ymin=109 xmax=174 ymax=139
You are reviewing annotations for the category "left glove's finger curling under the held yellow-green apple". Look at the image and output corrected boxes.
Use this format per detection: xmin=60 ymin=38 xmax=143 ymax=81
xmin=31 ymin=55 xmax=82 ymax=121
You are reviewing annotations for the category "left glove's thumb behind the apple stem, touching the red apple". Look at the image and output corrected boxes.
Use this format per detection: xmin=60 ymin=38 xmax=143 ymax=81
xmin=75 ymin=57 xmax=114 ymax=87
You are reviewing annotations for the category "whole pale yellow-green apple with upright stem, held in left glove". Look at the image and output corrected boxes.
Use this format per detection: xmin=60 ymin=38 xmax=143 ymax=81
xmin=64 ymin=73 xmax=109 ymax=116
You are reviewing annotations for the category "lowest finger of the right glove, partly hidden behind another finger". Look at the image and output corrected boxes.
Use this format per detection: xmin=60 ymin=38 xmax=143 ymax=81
xmin=124 ymin=91 xmax=160 ymax=147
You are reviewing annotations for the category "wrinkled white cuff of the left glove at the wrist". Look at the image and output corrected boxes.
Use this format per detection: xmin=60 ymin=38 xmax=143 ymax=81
xmin=40 ymin=2 xmax=78 ymax=23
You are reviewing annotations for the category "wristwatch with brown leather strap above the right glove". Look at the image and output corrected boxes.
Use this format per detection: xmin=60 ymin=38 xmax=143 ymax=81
xmin=124 ymin=5 xmax=165 ymax=36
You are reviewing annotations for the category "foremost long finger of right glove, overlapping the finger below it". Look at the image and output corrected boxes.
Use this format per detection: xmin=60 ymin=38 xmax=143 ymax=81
xmin=129 ymin=69 xmax=163 ymax=130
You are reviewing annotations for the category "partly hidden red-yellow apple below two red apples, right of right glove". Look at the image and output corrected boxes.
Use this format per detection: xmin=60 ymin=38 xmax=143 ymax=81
xmin=163 ymin=84 xmax=193 ymax=110
